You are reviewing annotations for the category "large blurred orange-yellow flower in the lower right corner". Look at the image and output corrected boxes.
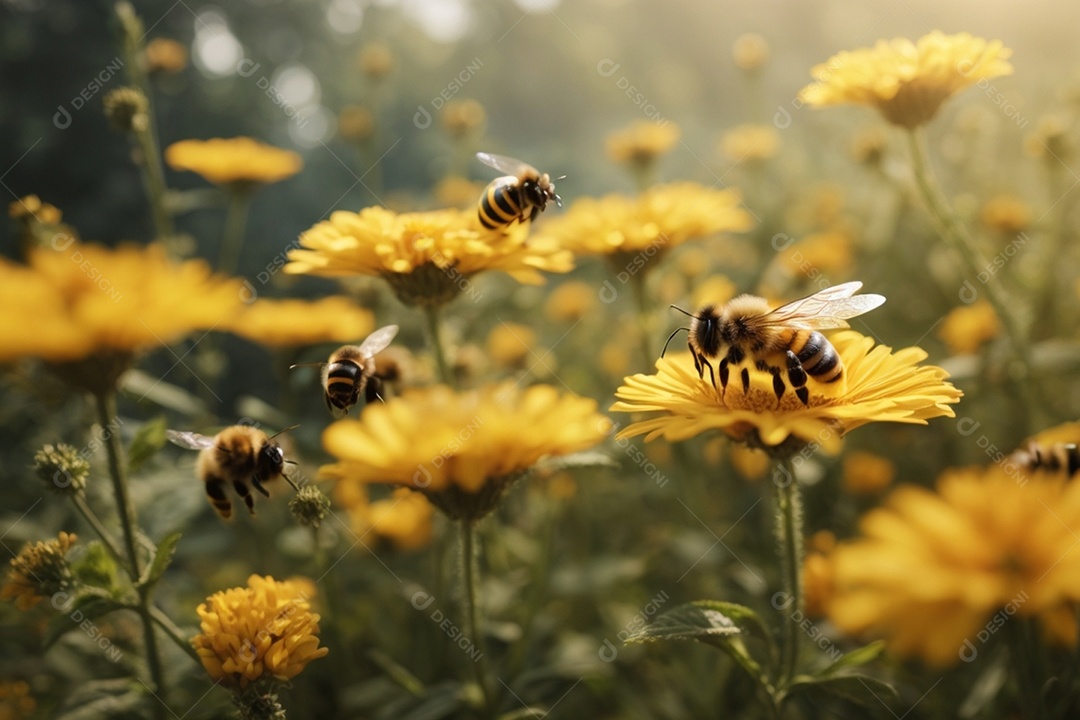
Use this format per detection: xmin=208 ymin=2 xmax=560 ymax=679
xmin=828 ymin=465 xmax=1080 ymax=666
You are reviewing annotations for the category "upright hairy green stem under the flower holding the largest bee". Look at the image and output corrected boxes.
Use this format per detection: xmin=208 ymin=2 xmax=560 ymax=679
xmin=772 ymin=460 xmax=802 ymax=688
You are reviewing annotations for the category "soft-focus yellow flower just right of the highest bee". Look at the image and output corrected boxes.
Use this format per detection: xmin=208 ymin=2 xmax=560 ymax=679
xmin=530 ymin=182 xmax=754 ymax=260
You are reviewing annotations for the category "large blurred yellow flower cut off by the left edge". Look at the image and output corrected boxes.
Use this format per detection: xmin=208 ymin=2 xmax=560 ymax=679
xmin=0 ymin=242 xmax=243 ymax=361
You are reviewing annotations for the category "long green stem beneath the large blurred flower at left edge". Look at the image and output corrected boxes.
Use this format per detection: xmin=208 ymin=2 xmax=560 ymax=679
xmin=94 ymin=391 xmax=166 ymax=718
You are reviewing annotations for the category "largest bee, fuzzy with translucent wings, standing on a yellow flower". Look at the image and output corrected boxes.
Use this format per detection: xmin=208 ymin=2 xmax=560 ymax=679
xmin=661 ymin=282 xmax=885 ymax=405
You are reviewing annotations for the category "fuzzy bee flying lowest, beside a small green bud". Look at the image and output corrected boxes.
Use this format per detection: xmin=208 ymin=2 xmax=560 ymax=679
xmin=165 ymin=425 xmax=298 ymax=520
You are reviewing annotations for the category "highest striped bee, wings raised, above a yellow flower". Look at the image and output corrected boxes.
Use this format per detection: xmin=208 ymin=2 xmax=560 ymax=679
xmin=476 ymin=152 xmax=563 ymax=230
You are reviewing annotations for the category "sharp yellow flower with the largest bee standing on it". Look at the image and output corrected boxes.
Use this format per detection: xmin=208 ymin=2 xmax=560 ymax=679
xmin=611 ymin=330 xmax=961 ymax=453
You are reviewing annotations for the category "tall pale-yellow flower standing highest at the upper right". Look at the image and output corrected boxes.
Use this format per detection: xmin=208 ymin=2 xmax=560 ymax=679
xmin=799 ymin=30 xmax=1013 ymax=128
